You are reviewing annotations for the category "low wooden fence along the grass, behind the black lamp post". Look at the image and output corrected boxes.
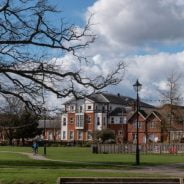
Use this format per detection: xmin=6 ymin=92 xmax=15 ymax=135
xmin=92 ymin=143 xmax=184 ymax=154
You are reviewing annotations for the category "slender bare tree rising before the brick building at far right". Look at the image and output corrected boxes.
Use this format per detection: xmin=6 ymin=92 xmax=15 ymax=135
xmin=159 ymin=72 xmax=181 ymax=143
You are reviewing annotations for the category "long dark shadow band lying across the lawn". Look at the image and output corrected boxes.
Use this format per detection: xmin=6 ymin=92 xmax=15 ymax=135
xmin=0 ymin=160 xmax=175 ymax=170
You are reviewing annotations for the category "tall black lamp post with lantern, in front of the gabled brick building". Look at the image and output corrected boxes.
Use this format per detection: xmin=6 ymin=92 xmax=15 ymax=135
xmin=133 ymin=79 xmax=142 ymax=165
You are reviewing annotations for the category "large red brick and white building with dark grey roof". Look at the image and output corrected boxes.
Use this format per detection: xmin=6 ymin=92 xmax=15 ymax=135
xmin=61 ymin=93 xmax=154 ymax=143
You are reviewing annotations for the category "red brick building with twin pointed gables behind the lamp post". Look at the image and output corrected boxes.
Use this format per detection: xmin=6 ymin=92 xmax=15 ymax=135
xmin=127 ymin=105 xmax=184 ymax=144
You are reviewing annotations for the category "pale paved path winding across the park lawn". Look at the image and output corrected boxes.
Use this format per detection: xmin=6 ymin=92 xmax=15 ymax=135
xmin=0 ymin=151 xmax=184 ymax=177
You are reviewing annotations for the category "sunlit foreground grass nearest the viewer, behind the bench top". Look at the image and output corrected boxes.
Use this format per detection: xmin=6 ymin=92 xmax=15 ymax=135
xmin=0 ymin=168 xmax=167 ymax=184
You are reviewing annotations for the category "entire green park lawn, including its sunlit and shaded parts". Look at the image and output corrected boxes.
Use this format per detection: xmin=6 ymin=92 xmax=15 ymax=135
xmin=0 ymin=146 xmax=184 ymax=184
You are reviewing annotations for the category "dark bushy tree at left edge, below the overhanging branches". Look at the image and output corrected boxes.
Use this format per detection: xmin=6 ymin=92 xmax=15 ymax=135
xmin=0 ymin=97 xmax=42 ymax=145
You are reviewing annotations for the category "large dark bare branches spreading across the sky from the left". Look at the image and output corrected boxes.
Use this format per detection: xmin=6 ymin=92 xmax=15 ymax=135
xmin=0 ymin=0 xmax=124 ymax=111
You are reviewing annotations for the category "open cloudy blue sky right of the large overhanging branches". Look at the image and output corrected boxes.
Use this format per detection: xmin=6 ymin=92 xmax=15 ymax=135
xmin=46 ymin=0 xmax=184 ymax=108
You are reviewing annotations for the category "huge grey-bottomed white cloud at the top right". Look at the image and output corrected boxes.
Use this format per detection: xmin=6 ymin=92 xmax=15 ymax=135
xmin=88 ymin=0 xmax=184 ymax=49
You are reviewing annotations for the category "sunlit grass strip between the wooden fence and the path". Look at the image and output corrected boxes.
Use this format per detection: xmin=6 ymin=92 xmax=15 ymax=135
xmin=43 ymin=147 xmax=184 ymax=165
